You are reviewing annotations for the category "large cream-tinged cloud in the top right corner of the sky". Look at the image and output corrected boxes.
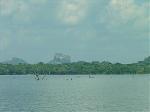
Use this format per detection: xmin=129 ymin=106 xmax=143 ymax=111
xmin=100 ymin=0 xmax=150 ymax=28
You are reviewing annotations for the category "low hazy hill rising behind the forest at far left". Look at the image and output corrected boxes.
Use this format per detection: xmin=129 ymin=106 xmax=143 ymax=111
xmin=2 ymin=57 xmax=27 ymax=65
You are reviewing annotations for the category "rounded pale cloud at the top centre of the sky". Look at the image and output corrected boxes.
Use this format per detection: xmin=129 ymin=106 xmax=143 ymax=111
xmin=58 ymin=0 xmax=88 ymax=25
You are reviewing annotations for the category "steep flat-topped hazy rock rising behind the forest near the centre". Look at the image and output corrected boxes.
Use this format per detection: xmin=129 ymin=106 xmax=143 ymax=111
xmin=49 ymin=53 xmax=71 ymax=64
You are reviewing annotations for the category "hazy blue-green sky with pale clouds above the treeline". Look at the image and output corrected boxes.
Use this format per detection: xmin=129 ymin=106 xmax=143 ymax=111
xmin=0 ymin=0 xmax=150 ymax=63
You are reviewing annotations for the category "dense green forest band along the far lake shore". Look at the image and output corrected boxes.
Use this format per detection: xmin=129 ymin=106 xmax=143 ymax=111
xmin=0 ymin=56 xmax=150 ymax=75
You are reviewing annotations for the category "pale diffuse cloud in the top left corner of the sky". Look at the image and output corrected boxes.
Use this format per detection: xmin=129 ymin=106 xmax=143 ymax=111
xmin=0 ymin=0 xmax=47 ymax=20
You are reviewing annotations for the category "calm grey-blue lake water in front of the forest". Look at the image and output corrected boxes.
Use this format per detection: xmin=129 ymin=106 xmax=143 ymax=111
xmin=0 ymin=75 xmax=150 ymax=112
